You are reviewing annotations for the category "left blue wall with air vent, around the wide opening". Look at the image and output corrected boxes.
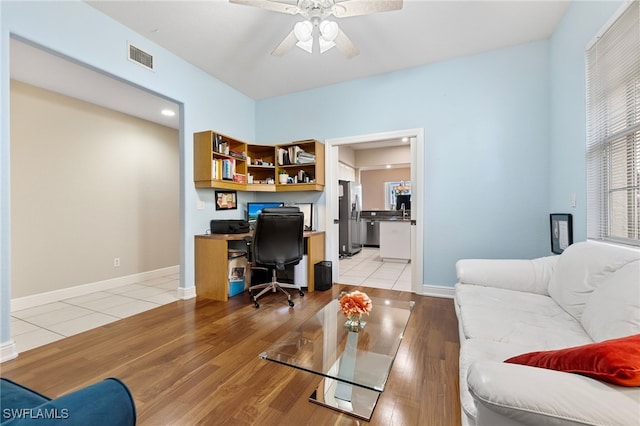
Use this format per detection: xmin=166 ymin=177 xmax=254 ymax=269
xmin=0 ymin=1 xmax=255 ymax=356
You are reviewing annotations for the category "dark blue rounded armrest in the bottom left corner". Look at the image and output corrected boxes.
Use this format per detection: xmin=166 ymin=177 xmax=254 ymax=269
xmin=2 ymin=378 xmax=136 ymax=426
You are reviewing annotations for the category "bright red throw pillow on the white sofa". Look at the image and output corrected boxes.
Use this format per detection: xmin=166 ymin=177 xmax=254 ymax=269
xmin=505 ymin=334 xmax=640 ymax=386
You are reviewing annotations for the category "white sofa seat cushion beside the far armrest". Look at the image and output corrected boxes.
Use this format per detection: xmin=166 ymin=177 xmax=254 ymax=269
xmin=455 ymin=284 xmax=593 ymax=350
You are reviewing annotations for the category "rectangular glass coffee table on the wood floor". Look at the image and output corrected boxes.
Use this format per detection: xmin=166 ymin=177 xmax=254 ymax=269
xmin=260 ymin=297 xmax=415 ymax=420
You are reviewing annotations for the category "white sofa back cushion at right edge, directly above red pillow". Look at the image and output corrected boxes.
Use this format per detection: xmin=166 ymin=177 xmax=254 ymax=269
xmin=580 ymin=260 xmax=640 ymax=342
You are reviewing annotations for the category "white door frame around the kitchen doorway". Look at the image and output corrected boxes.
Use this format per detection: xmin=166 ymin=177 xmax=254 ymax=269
xmin=324 ymin=128 xmax=424 ymax=294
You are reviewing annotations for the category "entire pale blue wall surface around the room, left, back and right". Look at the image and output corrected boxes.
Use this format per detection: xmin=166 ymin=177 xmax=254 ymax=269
xmin=0 ymin=1 xmax=620 ymax=354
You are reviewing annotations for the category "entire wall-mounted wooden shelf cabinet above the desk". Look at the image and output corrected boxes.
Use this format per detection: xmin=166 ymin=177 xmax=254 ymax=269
xmin=193 ymin=130 xmax=324 ymax=192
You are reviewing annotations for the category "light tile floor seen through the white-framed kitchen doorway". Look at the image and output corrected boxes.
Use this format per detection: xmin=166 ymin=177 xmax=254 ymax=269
xmin=338 ymin=247 xmax=412 ymax=291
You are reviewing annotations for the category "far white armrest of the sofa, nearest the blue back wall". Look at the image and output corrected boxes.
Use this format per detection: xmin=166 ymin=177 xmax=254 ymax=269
xmin=456 ymin=256 xmax=558 ymax=295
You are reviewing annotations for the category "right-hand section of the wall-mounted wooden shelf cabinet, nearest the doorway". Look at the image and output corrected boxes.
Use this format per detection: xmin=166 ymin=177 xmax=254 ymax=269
xmin=276 ymin=140 xmax=324 ymax=192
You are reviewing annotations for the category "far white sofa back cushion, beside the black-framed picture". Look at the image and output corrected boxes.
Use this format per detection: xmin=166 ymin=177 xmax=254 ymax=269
xmin=549 ymin=242 xmax=640 ymax=320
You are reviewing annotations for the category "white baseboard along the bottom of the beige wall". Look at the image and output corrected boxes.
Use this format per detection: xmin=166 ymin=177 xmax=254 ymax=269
xmin=11 ymin=265 xmax=180 ymax=312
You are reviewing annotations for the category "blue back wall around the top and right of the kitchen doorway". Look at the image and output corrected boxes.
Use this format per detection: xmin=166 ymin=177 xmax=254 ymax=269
xmin=256 ymin=41 xmax=549 ymax=286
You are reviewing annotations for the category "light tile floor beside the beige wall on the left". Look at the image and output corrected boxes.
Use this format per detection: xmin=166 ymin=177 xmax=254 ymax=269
xmin=11 ymin=274 xmax=179 ymax=353
